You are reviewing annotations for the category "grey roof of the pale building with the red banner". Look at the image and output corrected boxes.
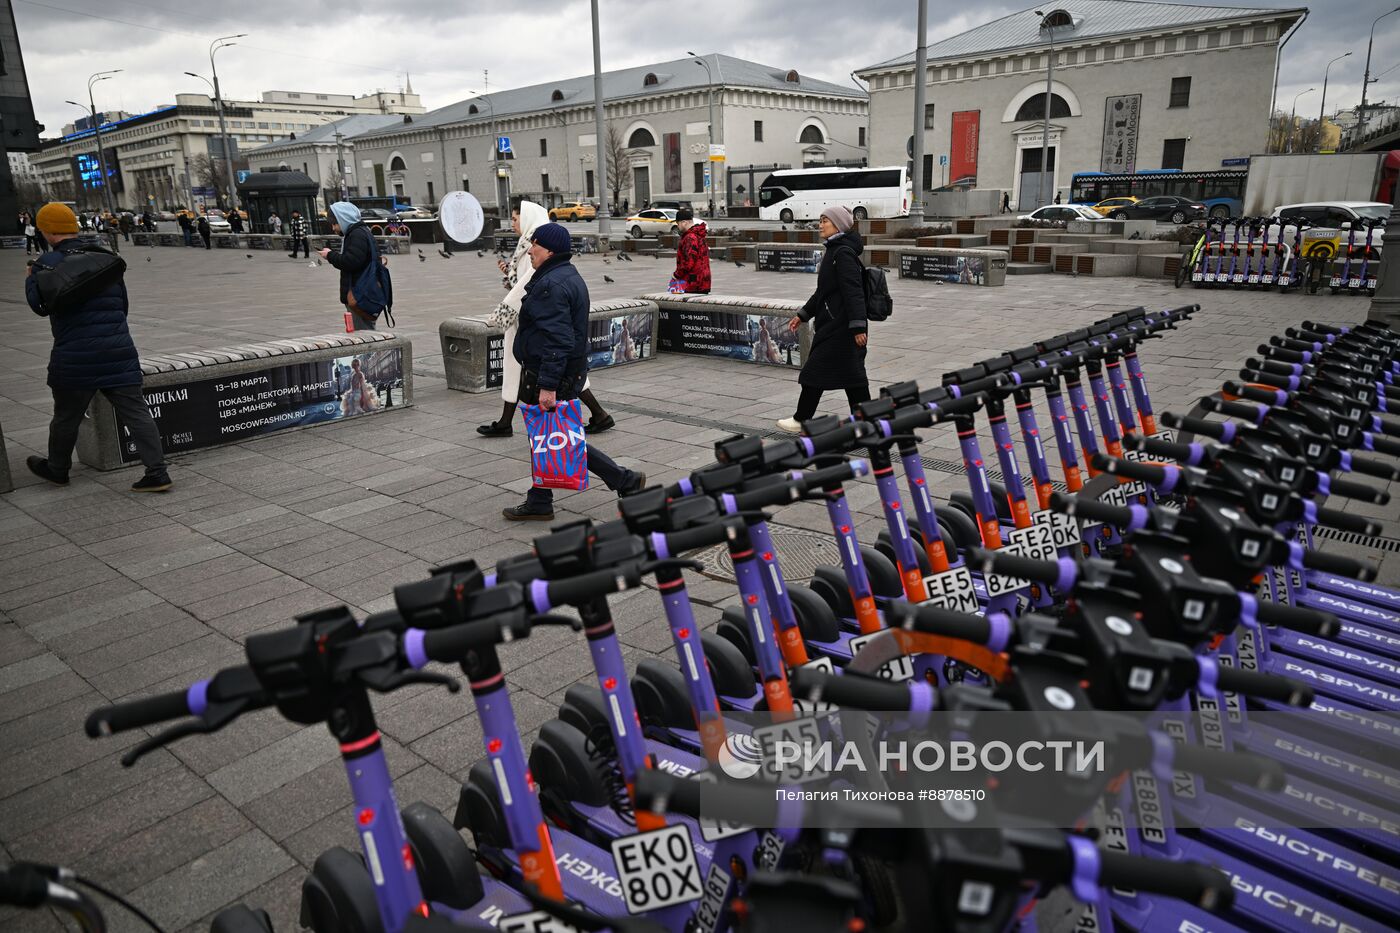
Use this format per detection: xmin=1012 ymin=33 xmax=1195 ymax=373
xmin=857 ymin=0 xmax=1306 ymax=73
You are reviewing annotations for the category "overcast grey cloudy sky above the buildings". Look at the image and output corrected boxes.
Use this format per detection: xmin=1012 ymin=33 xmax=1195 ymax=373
xmin=13 ymin=0 xmax=1400 ymax=136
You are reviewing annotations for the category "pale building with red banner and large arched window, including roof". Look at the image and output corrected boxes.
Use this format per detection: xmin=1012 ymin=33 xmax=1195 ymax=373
xmin=855 ymin=0 xmax=1308 ymax=209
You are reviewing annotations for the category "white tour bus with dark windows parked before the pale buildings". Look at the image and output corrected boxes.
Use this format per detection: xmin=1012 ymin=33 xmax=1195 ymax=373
xmin=759 ymin=165 xmax=913 ymax=223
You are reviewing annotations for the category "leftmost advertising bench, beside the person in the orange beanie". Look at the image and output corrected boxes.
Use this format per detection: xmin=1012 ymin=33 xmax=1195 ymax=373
xmin=78 ymin=331 xmax=413 ymax=469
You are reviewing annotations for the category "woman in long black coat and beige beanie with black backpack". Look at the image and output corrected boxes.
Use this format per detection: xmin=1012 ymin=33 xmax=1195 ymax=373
xmin=778 ymin=206 xmax=871 ymax=434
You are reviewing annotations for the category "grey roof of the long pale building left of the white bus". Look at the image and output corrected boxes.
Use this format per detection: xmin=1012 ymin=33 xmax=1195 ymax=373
xmin=350 ymin=55 xmax=867 ymax=137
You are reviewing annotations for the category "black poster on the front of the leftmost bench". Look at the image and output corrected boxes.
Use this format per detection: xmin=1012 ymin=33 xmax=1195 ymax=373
xmin=116 ymin=347 xmax=403 ymax=464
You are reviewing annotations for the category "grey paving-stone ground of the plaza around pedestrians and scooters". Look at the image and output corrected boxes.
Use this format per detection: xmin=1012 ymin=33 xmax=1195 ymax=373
xmin=0 ymin=240 xmax=1400 ymax=933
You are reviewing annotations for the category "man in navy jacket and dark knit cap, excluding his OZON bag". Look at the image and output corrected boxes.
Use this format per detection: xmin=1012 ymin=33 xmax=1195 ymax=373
xmin=501 ymin=223 xmax=647 ymax=521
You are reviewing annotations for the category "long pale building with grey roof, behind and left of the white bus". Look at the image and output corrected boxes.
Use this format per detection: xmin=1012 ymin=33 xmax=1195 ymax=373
xmin=354 ymin=55 xmax=867 ymax=209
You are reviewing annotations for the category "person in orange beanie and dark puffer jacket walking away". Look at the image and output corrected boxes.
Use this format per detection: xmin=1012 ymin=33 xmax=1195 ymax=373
xmin=24 ymin=203 xmax=172 ymax=492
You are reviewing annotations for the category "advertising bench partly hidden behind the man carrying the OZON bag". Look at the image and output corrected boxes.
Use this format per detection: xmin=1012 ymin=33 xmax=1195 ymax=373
xmin=438 ymin=298 xmax=657 ymax=392
